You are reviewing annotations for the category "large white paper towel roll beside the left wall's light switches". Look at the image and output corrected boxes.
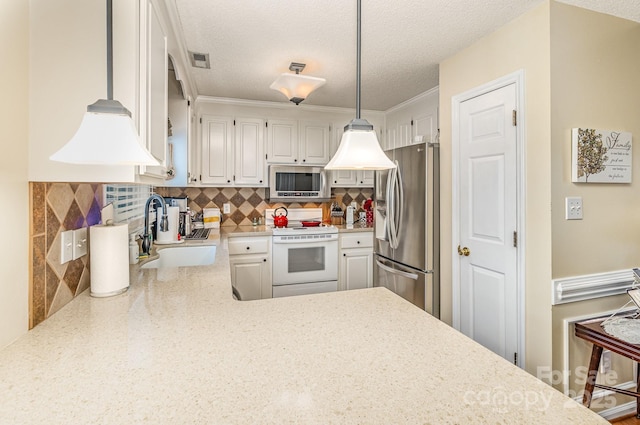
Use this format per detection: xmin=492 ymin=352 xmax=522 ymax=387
xmin=89 ymin=224 xmax=129 ymax=297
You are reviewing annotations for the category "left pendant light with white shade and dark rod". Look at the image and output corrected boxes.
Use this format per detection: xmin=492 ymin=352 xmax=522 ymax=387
xmin=49 ymin=0 xmax=160 ymax=165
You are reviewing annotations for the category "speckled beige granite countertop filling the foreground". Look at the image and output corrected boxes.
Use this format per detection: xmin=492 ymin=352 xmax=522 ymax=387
xmin=0 ymin=237 xmax=608 ymax=425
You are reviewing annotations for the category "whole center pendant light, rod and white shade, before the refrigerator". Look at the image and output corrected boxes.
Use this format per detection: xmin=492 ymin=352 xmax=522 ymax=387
xmin=324 ymin=0 xmax=395 ymax=170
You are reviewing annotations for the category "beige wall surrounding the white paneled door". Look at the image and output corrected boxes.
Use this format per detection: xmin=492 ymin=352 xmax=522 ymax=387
xmin=440 ymin=2 xmax=551 ymax=374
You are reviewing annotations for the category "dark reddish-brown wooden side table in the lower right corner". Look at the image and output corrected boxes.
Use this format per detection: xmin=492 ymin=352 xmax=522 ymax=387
xmin=575 ymin=319 xmax=640 ymax=419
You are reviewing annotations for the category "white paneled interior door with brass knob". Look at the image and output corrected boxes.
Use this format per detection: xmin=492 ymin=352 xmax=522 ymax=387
xmin=454 ymin=83 xmax=519 ymax=361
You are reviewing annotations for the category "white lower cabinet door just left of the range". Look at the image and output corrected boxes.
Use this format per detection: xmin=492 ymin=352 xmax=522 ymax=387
xmin=229 ymin=255 xmax=271 ymax=301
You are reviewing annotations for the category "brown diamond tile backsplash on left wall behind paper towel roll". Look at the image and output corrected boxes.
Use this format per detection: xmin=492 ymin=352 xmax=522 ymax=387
xmin=29 ymin=182 xmax=102 ymax=328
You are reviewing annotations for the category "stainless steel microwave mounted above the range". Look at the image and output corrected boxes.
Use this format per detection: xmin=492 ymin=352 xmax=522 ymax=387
xmin=268 ymin=164 xmax=331 ymax=202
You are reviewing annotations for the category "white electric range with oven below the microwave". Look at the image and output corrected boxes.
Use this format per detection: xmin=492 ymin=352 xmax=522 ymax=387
xmin=265 ymin=208 xmax=338 ymax=298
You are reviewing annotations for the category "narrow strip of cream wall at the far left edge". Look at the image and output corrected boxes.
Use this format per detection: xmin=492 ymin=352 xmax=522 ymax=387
xmin=0 ymin=0 xmax=29 ymax=347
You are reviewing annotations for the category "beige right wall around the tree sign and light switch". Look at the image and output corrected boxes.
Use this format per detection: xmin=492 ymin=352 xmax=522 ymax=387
xmin=551 ymin=3 xmax=640 ymax=401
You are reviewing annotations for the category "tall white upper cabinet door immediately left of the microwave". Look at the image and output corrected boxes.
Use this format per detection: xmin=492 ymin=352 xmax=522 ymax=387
xmin=233 ymin=118 xmax=266 ymax=186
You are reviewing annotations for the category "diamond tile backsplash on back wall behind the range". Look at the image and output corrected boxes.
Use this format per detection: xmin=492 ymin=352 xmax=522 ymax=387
xmin=155 ymin=187 xmax=373 ymax=226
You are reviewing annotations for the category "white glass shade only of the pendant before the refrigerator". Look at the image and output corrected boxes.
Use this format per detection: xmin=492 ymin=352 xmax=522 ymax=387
xmin=324 ymin=120 xmax=395 ymax=170
